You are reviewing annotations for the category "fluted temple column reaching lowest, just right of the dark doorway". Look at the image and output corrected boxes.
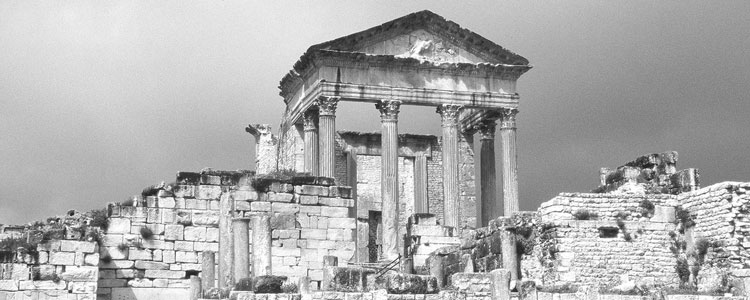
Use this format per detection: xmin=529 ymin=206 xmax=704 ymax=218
xmin=375 ymin=100 xmax=401 ymax=260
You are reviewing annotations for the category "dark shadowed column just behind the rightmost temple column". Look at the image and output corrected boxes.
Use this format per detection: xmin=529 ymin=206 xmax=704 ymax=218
xmin=477 ymin=120 xmax=501 ymax=227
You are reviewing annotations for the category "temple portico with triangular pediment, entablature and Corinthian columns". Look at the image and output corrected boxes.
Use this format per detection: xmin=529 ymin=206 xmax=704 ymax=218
xmin=268 ymin=12 xmax=531 ymax=259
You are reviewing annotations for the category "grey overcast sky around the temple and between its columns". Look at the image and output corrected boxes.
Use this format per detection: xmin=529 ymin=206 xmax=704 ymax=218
xmin=0 ymin=0 xmax=750 ymax=224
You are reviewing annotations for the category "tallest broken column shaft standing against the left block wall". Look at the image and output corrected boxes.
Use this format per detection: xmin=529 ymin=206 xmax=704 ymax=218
xmin=219 ymin=193 xmax=234 ymax=289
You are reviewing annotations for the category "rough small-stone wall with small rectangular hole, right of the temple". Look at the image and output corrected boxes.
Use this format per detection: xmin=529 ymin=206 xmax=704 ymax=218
xmin=539 ymin=216 xmax=679 ymax=287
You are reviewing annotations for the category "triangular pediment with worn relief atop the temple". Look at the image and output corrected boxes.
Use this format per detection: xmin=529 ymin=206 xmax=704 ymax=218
xmin=308 ymin=10 xmax=529 ymax=65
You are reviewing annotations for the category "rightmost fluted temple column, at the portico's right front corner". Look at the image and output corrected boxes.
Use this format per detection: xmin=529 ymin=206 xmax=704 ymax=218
xmin=500 ymin=108 xmax=518 ymax=217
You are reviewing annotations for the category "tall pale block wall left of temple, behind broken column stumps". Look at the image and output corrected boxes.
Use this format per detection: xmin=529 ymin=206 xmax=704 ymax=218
xmin=92 ymin=171 xmax=356 ymax=299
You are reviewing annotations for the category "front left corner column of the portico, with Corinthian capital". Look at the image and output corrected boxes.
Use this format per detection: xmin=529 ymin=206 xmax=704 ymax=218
xmin=316 ymin=97 xmax=340 ymax=178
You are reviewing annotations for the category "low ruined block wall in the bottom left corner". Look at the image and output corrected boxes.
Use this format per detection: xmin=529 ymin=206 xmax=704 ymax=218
xmin=0 ymin=240 xmax=99 ymax=300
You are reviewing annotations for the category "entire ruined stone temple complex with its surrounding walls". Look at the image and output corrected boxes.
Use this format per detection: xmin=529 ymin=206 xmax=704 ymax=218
xmin=0 ymin=11 xmax=750 ymax=300
